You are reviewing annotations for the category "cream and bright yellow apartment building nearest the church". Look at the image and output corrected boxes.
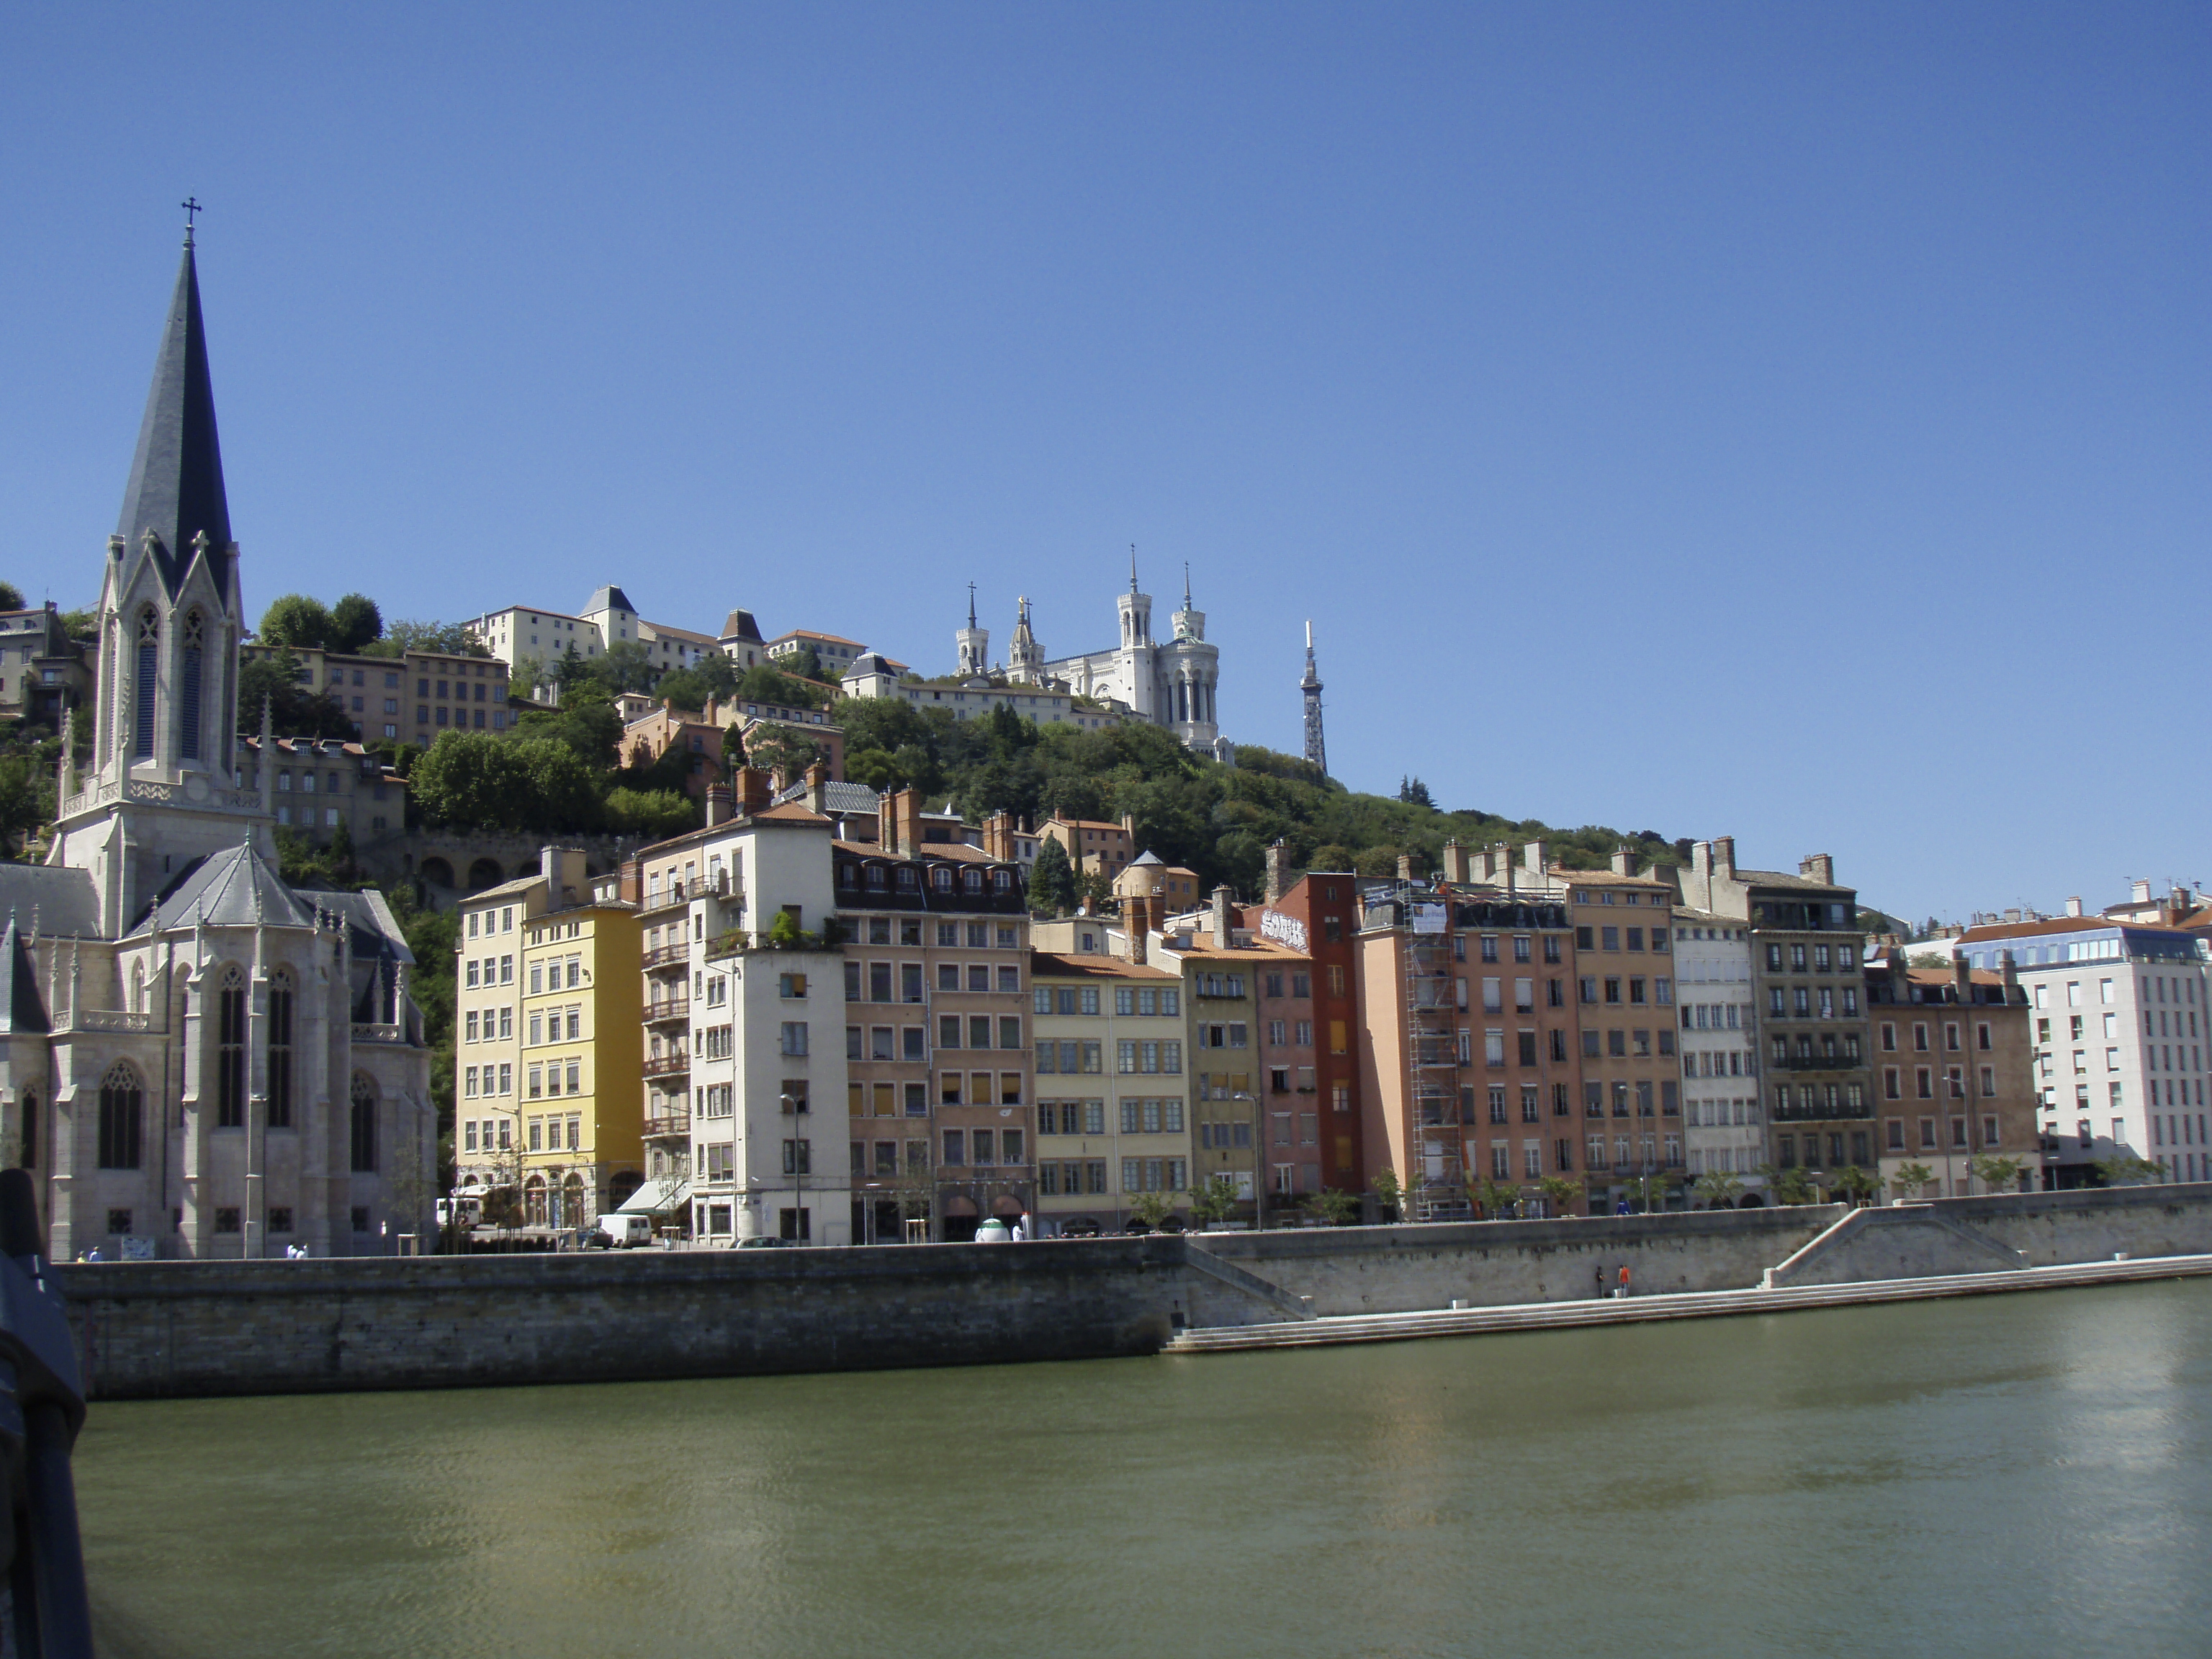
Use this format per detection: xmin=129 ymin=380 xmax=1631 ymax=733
xmin=454 ymin=848 xmax=644 ymax=1228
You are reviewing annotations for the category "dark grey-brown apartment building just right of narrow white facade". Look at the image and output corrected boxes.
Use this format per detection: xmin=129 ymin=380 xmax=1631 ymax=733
xmin=1672 ymin=836 xmax=1878 ymax=1188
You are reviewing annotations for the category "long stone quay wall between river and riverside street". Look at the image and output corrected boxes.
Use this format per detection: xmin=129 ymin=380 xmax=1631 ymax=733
xmin=58 ymin=1186 xmax=2212 ymax=1401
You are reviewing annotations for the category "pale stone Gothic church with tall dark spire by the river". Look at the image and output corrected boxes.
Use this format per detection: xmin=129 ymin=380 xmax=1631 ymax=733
xmin=0 ymin=230 xmax=436 ymax=1259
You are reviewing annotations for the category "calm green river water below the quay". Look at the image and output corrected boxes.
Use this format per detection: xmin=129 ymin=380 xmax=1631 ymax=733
xmin=78 ymin=1281 xmax=2212 ymax=1659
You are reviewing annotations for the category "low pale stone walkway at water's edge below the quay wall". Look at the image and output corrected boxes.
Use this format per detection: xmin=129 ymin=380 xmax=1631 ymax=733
xmin=1164 ymin=1254 xmax=2212 ymax=1354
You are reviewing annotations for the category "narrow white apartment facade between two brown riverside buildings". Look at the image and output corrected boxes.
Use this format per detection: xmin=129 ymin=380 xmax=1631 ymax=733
xmin=1675 ymin=907 xmax=1772 ymax=1205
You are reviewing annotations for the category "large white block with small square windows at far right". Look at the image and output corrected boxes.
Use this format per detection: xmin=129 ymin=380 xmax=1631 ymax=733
xmin=1951 ymin=916 xmax=2212 ymax=1188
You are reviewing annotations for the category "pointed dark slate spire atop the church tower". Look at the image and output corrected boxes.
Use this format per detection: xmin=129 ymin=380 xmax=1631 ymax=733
xmin=115 ymin=230 xmax=230 ymax=593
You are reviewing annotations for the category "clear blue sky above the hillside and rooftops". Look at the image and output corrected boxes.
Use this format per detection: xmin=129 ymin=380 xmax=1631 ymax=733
xmin=0 ymin=4 xmax=2212 ymax=916
